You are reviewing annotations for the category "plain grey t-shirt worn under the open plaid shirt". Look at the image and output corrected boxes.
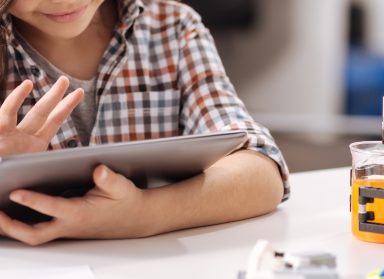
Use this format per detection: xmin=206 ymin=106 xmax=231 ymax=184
xmin=16 ymin=33 xmax=97 ymax=145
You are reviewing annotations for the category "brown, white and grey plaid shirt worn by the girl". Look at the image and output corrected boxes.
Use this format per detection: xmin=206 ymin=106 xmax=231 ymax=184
xmin=1 ymin=0 xmax=289 ymax=200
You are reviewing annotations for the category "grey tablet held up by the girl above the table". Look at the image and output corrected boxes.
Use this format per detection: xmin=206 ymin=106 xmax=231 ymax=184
xmin=0 ymin=130 xmax=247 ymax=221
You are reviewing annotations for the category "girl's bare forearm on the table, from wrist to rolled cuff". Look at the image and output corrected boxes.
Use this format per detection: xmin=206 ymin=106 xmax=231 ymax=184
xmin=143 ymin=150 xmax=283 ymax=235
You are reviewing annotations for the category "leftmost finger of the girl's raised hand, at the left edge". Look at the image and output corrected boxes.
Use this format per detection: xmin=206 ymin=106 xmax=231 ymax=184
xmin=0 ymin=80 xmax=33 ymax=133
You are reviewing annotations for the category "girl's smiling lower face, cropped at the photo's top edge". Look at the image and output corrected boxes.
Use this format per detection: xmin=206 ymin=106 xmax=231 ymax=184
xmin=9 ymin=0 xmax=104 ymax=39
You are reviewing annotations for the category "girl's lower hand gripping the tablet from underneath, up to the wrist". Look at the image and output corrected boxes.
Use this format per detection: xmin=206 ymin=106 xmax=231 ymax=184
xmin=0 ymin=165 xmax=148 ymax=245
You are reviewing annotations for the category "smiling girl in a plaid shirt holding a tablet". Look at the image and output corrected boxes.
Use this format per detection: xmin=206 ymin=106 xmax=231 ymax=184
xmin=0 ymin=0 xmax=289 ymax=245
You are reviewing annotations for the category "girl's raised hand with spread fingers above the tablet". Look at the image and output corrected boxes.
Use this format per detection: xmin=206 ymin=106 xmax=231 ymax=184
xmin=0 ymin=77 xmax=84 ymax=156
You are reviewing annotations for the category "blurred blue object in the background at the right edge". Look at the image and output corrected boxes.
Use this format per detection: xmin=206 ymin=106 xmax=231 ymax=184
xmin=345 ymin=47 xmax=384 ymax=116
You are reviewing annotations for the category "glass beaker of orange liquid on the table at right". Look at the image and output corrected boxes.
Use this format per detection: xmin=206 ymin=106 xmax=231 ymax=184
xmin=349 ymin=141 xmax=384 ymax=243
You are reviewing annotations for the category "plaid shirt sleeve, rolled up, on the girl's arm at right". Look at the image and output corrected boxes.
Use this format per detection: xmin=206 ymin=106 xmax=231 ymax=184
xmin=178 ymin=3 xmax=290 ymax=201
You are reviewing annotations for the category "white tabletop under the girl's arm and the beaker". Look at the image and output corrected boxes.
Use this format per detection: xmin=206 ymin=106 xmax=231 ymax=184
xmin=0 ymin=168 xmax=384 ymax=279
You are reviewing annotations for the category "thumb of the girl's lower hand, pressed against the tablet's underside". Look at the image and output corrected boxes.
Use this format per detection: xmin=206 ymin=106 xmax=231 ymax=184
xmin=93 ymin=165 xmax=134 ymax=200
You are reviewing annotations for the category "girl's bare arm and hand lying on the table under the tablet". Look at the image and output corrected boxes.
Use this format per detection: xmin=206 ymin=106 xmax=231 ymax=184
xmin=0 ymin=150 xmax=283 ymax=245
